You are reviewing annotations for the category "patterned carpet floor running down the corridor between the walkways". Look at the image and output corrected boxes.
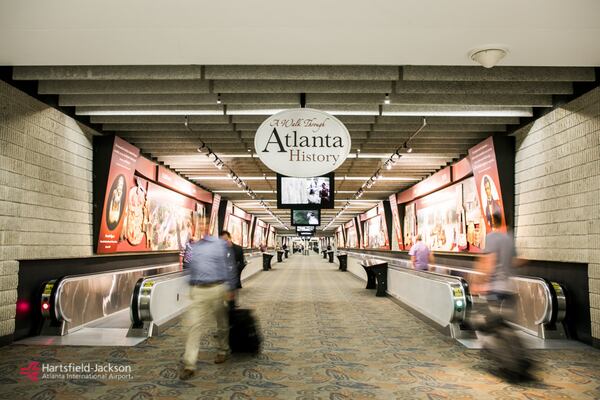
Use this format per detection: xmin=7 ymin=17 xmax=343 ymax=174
xmin=0 ymin=255 xmax=600 ymax=400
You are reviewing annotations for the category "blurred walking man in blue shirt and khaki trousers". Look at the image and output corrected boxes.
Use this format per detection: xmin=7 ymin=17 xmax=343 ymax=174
xmin=179 ymin=230 xmax=236 ymax=380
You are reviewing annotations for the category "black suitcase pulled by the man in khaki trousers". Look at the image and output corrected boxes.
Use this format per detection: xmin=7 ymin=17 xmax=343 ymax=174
xmin=229 ymin=308 xmax=262 ymax=354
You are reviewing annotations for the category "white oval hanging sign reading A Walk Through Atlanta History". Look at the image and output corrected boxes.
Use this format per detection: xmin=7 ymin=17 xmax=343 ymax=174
xmin=254 ymin=108 xmax=351 ymax=178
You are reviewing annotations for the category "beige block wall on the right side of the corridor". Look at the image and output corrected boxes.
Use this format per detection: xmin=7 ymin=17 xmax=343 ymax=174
xmin=515 ymin=88 xmax=600 ymax=339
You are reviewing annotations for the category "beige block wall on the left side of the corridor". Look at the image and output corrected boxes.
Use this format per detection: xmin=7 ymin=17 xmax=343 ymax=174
xmin=0 ymin=81 xmax=95 ymax=337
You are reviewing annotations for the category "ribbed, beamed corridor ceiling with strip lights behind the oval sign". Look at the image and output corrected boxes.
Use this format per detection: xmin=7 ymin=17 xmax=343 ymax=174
xmin=13 ymin=65 xmax=595 ymax=228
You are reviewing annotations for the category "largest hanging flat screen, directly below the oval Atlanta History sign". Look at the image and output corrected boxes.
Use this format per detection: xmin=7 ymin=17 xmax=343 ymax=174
xmin=277 ymin=173 xmax=335 ymax=210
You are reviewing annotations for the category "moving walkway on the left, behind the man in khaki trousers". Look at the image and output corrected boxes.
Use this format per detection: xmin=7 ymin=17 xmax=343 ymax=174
xmin=18 ymin=252 xmax=268 ymax=346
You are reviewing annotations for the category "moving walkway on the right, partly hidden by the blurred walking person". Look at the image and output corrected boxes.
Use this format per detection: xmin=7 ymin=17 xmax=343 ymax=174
xmin=348 ymin=251 xmax=577 ymax=347
